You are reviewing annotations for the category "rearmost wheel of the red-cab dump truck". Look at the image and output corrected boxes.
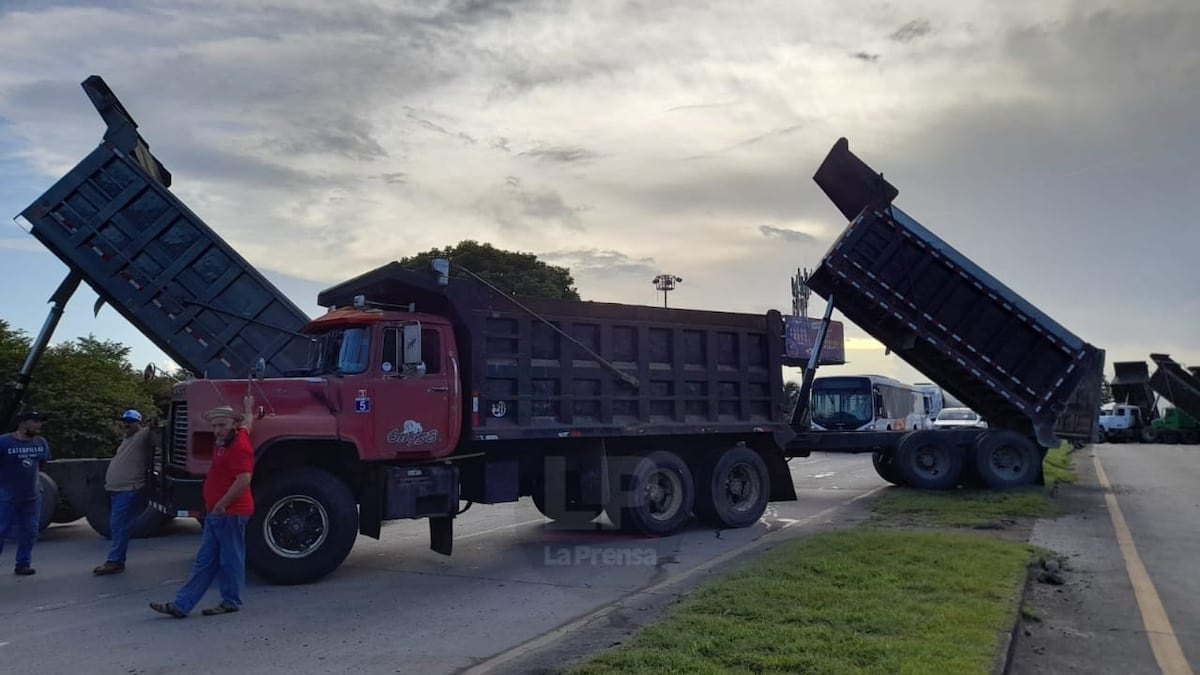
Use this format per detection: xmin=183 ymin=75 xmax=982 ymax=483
xmin=694 ymin=446 xmax=770 ymax=527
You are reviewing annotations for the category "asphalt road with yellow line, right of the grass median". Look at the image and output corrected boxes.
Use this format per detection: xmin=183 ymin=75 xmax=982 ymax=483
xmin=1010 ymin=444 xmax=1200 ymax=675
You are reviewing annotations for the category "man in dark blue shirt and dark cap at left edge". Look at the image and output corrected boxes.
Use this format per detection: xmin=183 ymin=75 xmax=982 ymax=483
xmin=0 ymin=411 xmax=50 ymax=577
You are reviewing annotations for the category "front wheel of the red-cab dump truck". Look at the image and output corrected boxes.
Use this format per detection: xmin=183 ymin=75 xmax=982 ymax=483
xmin=246 ymin=467 xmax=359 ymax=584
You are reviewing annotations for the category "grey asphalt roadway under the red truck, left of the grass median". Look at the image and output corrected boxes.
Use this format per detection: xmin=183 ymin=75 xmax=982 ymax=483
xmin=0 ymin=454 xmax=884 ymax=674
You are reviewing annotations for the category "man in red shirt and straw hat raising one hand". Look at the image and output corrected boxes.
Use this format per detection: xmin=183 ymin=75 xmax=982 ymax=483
xmin=150 ymin=396 xmax=254 ymax=619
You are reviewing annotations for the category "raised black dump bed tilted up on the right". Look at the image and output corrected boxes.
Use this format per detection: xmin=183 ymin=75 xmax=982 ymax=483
xmin=809 ymin=138 xmax=1104 ymax=447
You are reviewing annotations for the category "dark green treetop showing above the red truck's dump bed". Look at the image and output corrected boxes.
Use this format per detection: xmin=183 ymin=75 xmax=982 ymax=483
xmin=400 ymin=239 xmax=580 ymax=300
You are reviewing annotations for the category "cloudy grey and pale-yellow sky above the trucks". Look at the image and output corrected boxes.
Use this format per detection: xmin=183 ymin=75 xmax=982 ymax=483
xmin=0 ymin=0 xmax=1200 ymax=389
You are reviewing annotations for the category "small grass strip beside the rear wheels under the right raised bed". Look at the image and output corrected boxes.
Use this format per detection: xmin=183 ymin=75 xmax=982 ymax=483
xmin=875 ymin=486 xmax=1057 ymax=527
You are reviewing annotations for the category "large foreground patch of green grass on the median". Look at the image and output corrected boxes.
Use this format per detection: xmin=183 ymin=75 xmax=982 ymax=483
xmin=568 ymin=528 xmax=1033 ymax=675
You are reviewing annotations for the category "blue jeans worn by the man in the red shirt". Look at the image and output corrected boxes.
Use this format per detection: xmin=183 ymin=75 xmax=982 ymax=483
xmin=175 ymin=513 xmax=250 ymax=611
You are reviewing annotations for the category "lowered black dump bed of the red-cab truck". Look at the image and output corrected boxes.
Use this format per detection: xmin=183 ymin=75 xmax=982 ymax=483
xmin=318 ymin=263 xmax=792 ymax=446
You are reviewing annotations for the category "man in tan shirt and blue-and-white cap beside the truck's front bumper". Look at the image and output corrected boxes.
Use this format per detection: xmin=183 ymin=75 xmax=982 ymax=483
xmin=91 ymin=410 xmax=157 ymax=577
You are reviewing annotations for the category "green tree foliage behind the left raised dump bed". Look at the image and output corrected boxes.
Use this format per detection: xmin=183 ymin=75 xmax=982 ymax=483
xmin=0 ymin=319 xmax=172 ymax=458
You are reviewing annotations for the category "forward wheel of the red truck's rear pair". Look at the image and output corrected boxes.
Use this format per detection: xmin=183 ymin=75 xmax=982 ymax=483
xmin=605 ymin=450 xmax=696 ymax=537
